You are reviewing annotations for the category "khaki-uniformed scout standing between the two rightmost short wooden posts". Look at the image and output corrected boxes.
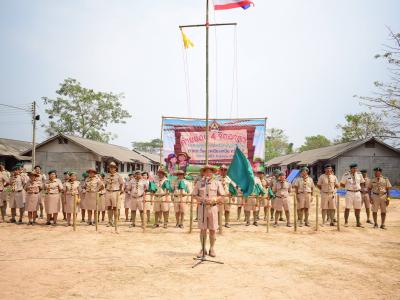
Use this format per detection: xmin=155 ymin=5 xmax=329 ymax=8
xmin=317 ymin=164 xmax=339 ymax=226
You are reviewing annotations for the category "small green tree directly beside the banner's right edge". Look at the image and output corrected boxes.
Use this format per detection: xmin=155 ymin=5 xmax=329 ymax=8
xmin=265 ymin=128 xmax=293 ymax=161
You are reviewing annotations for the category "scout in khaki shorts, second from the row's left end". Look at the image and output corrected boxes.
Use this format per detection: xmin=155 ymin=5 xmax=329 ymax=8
xmin=9 ymin=165 xmax=26 ymax=224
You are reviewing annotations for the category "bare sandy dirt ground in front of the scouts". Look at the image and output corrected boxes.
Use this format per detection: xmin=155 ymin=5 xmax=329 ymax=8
xmin=0 ymin=200 xmax=400 ymax=300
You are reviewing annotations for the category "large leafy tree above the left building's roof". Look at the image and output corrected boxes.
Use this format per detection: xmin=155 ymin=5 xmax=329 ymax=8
xmin=42 ymin=78 xmax=131 ymax=142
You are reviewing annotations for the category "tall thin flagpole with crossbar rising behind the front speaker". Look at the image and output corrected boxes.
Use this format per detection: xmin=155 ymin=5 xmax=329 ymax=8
xmin=179 ymin=0 xmax=237 ymax=164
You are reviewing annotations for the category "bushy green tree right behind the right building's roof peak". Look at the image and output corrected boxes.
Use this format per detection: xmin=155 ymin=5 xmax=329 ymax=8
xmin=336 ymin=112 xmax=394 ymax=143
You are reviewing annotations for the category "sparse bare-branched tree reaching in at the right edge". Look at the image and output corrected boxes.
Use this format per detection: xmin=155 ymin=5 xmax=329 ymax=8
xmin=355 ymin=28 xmax=400 ymax=144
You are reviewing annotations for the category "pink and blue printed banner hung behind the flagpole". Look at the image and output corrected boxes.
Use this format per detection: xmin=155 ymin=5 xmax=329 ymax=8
xmin=162 ymin=118 xmax=266 ymax=174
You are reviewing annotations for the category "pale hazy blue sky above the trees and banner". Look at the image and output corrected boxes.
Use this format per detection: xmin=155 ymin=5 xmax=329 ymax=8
xmin=0 ymin=0 xmax=400 ymax=146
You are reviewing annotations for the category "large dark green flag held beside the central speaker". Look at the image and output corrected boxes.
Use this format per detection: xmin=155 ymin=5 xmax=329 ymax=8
xmin=228 ymin=147 xmax=254 ymax=197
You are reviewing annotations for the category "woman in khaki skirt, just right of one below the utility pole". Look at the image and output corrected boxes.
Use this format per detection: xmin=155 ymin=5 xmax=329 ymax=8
xmin=44 ymin=170 xmax=64 ymax=225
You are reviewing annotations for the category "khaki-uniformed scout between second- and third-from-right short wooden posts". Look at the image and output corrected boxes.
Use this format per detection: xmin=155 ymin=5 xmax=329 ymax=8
xmin=293 ymin=167 xmax=314 ymax=227
